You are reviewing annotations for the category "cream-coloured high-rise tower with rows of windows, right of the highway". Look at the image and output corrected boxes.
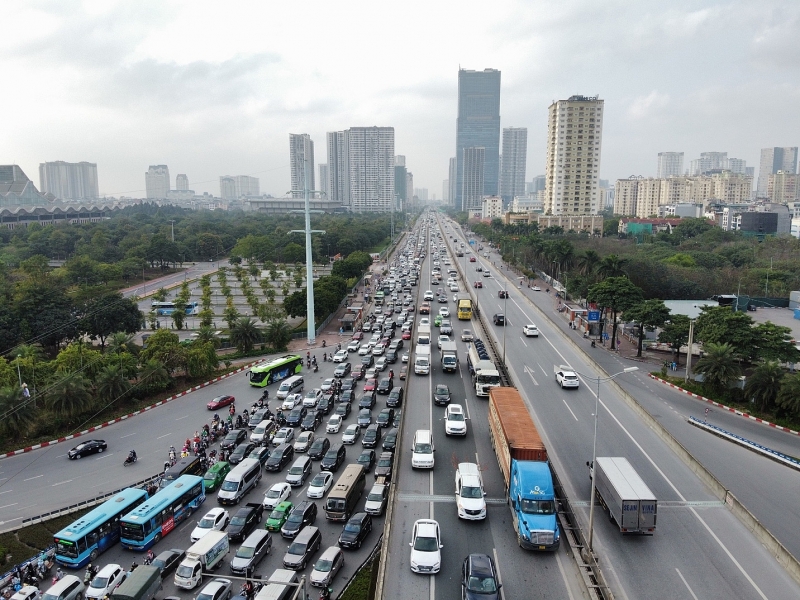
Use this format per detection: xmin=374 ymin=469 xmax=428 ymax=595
xmin=544 ymin=96 xmax=604 ymax=215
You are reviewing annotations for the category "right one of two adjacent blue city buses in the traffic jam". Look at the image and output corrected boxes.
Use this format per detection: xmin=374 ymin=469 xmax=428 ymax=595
xmin=120 ymin=475 xmax=206 ymax=550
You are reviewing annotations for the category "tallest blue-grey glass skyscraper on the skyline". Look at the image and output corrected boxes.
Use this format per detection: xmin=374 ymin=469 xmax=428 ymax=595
xmin=451 ymin=69 xmax=500 ymax=210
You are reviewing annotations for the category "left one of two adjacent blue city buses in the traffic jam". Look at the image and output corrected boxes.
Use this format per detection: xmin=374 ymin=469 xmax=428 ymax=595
xmin=54 ymin=488 xmax=147 ymax=569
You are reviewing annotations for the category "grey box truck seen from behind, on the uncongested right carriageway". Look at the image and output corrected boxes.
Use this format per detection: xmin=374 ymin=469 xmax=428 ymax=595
xmin=586 ymin=456 xmax=658 ymax=535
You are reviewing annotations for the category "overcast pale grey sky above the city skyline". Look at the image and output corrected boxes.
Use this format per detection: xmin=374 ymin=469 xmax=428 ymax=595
xmin=0 ymin=0 xmax=800 ymax=198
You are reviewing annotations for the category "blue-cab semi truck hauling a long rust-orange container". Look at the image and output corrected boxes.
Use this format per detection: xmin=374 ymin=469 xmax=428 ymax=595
xmin=489 ymin=387 xmax=561 ymax=551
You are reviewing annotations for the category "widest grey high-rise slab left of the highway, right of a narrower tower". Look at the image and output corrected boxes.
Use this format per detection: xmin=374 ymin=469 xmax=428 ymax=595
xmin=346 ymin=127 xmax=395 ymax=212
